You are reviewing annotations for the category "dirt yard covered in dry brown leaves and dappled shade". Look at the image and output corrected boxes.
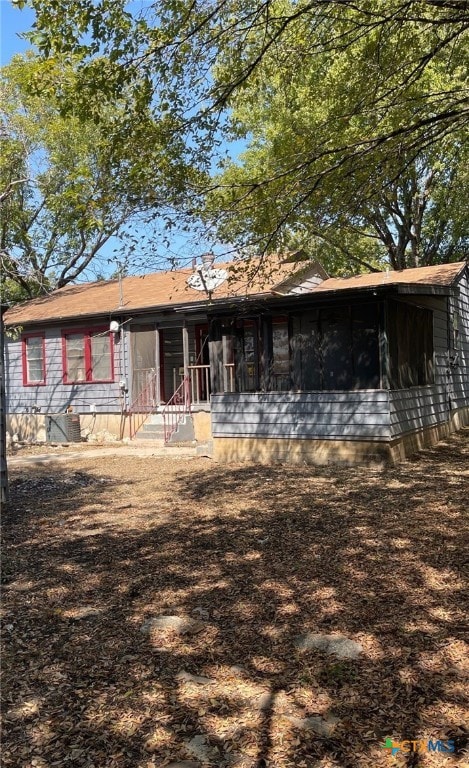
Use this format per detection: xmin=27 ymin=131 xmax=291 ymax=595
xmin=2 ymin=430 xmax=469 ymax=768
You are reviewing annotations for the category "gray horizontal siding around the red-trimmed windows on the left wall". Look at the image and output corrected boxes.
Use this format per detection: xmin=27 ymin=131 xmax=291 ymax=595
xmin=5 ymin=326 xmax=122 ymax=413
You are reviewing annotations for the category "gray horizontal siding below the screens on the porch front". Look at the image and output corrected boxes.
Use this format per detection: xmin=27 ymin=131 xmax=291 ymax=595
xmin=211 ymin=390 xmax=390 ymax=440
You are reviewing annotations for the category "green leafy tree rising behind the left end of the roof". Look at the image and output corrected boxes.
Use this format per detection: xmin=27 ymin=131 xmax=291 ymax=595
xmin=0 ymin=55 xmax=203 ymax=301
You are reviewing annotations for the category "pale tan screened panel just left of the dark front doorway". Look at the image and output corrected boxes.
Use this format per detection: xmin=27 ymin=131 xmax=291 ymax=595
xmin=130 ymin=325 xmax=164 ymax=411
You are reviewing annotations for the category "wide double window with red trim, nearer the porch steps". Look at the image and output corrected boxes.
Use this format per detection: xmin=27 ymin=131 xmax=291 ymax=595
xmin=62 ymin=328 xmax=114 ymax=384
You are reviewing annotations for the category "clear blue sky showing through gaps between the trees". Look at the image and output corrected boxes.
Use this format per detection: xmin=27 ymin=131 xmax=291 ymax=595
xmin=0 ymin=0 xmax=236 ymax=279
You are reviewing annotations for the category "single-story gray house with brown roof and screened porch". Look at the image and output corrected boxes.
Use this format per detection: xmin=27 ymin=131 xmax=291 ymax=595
xmin=5 ymin=253 xmax=469 ymax=463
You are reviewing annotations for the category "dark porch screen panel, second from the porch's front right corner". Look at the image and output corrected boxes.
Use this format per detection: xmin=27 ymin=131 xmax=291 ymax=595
xmin=320 ymin=307 xmax=353 ymax=390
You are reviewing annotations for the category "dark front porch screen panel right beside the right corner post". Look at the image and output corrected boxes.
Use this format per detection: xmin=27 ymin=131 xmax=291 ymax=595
xmin=352 ymin=303 xmax=380 ymax=389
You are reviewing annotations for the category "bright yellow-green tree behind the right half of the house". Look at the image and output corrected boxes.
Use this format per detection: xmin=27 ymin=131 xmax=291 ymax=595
xmin=207 ymin=4 xmax=469 ymax=272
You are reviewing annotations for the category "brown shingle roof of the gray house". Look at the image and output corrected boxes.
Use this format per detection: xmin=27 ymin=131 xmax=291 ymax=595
xmin=5 ymin=257 xmax=465 ymax=325
